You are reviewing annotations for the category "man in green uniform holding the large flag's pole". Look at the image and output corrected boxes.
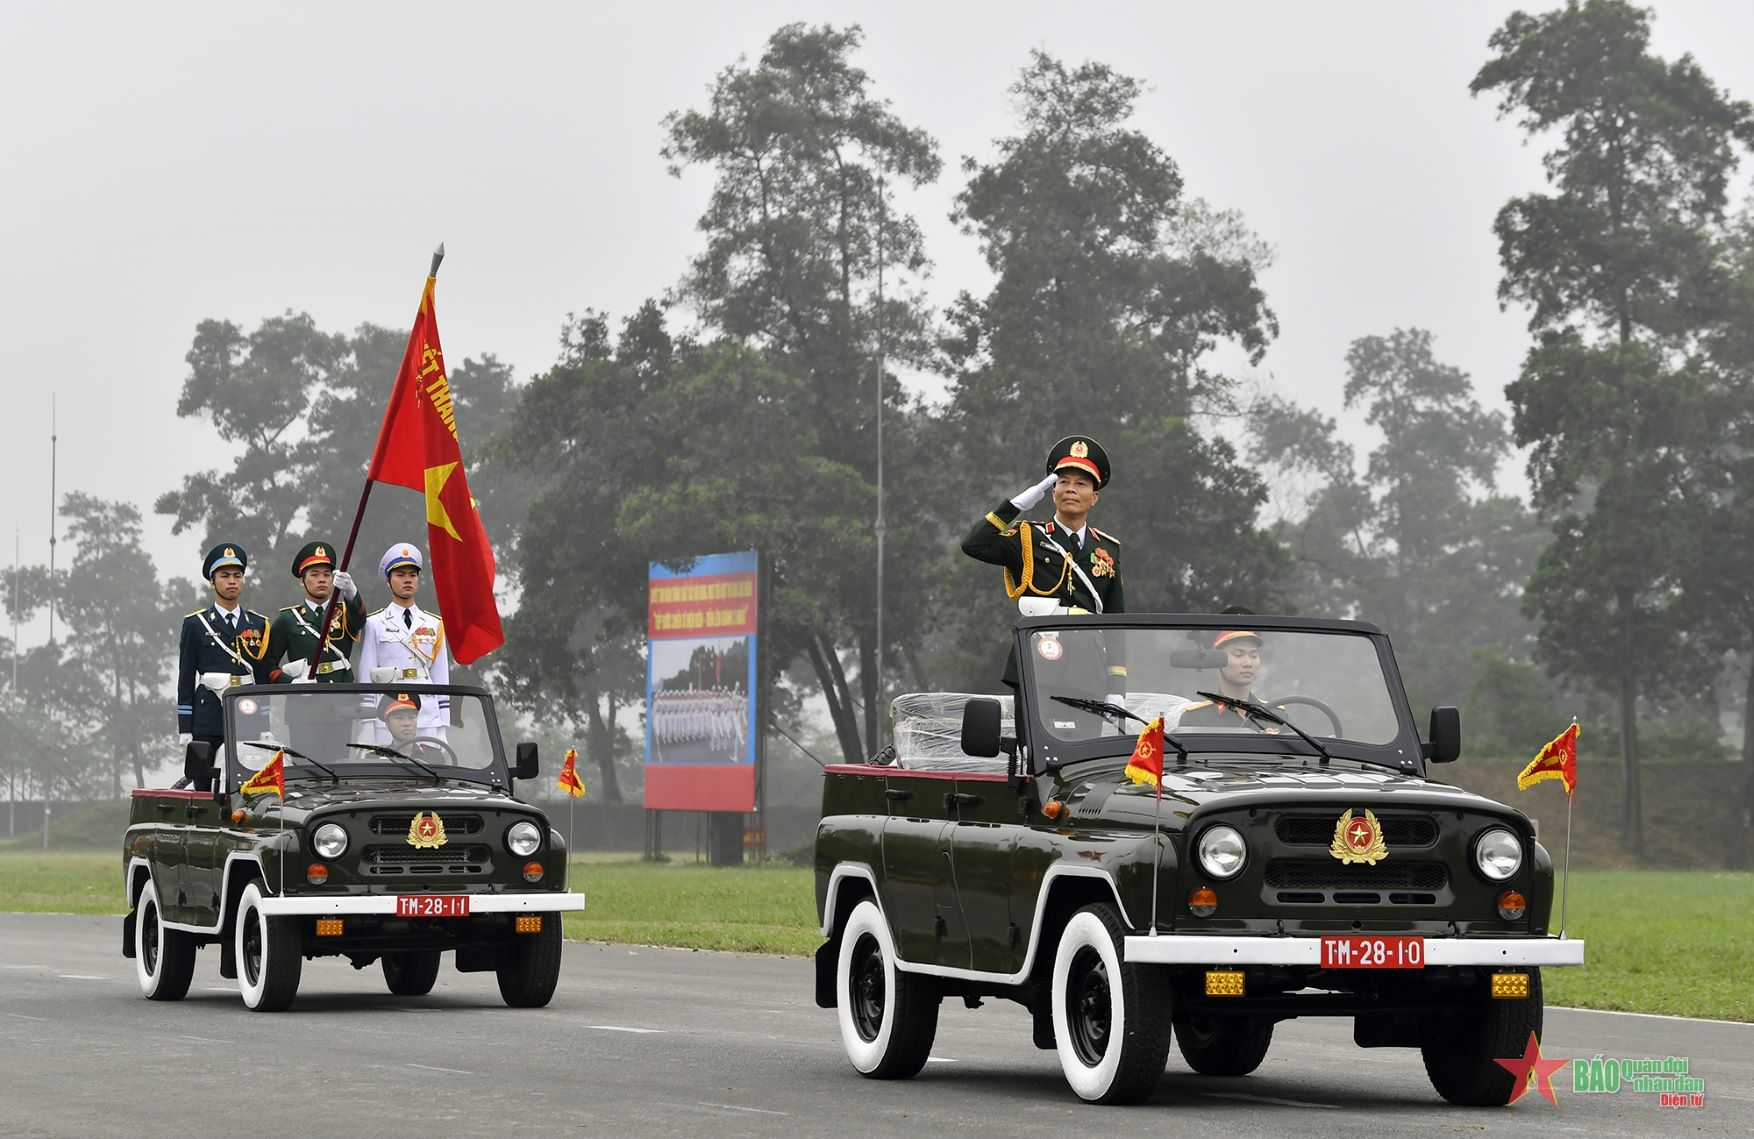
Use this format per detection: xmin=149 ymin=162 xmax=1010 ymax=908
xmin=265 ymin=542 xmax=365 ymax=760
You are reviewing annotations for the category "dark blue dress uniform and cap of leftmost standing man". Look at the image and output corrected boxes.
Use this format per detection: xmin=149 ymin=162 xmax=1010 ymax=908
xmin=177 ymin=542 xmax=268 ymax=749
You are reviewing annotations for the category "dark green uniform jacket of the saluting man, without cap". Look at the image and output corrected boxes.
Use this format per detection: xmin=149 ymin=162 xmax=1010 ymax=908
xmin=963 ymin=500 xmax=1126 ymax=691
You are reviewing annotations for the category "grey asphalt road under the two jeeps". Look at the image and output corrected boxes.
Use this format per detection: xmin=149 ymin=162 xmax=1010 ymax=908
xmin=0 ymin=914 xmax=1754 ymax=1139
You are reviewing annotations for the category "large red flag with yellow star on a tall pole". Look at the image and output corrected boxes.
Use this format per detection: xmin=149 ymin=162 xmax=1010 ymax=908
xmin=365 ymin=277 xmax=505 ymax=665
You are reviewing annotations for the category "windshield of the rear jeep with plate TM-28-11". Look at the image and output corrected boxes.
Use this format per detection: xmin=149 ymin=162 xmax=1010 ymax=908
xmin=226 ymin=684 xmax=507 ymax=788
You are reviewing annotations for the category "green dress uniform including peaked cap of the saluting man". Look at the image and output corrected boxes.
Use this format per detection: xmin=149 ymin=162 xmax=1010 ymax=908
xmin=963 ymin=435 xmax=1126 ymax=684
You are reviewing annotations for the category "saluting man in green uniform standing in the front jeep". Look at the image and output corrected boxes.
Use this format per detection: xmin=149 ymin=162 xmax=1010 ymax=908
xmin=963 ymin=435 xmax=1126 ymax=704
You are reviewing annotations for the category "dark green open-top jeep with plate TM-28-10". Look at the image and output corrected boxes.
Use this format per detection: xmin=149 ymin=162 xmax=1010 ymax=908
xmin=816 ymin=614 xmax=1584 ymax=1106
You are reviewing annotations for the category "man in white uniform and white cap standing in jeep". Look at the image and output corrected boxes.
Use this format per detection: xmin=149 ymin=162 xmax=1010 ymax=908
xmin=360 ymin=542 xmax=451 ymax=742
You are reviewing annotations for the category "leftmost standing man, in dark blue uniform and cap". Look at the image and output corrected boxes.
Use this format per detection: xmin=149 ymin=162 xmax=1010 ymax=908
xmin=177 ymin=542 xmax=268 ymax=751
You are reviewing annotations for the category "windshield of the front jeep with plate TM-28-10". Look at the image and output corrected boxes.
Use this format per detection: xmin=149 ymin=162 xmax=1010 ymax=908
xmin=1023 ymin=616 xmax=1417 ymax=767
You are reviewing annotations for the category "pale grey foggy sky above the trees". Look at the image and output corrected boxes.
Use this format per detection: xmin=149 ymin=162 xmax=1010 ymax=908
xmin=0 ymin=0 xmax=1754 ymax=614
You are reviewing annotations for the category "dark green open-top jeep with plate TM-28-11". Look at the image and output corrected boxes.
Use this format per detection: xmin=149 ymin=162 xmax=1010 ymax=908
xmin=123 ymin=684 xmax=584 ymax=1013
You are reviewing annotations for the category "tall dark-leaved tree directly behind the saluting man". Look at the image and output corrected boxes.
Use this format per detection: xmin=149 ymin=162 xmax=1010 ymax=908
xmin=938 ymin=51 xmax=1287 ymax=673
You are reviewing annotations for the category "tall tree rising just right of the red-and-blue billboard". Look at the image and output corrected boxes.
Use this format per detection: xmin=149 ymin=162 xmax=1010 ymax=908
xmin=647 ymin=25 xmax=940 ymax=758
